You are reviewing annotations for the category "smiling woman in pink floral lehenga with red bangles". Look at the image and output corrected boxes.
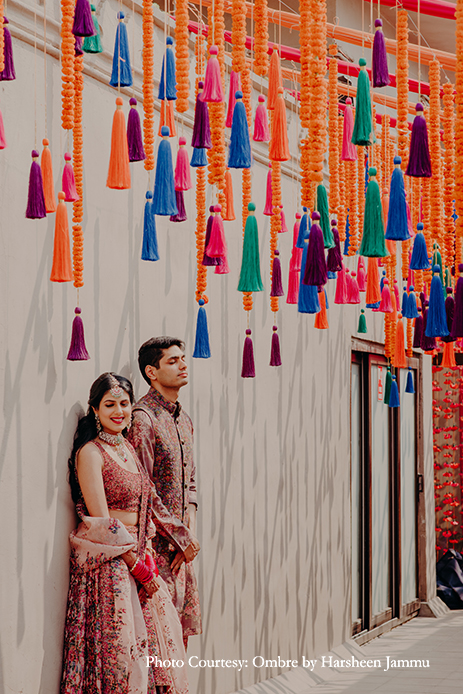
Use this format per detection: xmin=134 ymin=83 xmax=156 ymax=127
xmin=61 ymin=373 xmax=196 ymax=694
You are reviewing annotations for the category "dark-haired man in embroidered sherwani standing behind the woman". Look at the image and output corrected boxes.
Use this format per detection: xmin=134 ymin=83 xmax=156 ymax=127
xmin=129 ymin=337 xmax=201 ymax=649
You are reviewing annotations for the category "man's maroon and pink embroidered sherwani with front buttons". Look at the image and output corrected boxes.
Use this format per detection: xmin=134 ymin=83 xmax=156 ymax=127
xmin=129 ymin=388 xmax=201 ymax=637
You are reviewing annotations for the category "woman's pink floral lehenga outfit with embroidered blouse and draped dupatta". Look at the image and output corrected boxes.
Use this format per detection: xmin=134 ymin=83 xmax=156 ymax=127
xmin=61 ymin=441 xmax=188 ymax=694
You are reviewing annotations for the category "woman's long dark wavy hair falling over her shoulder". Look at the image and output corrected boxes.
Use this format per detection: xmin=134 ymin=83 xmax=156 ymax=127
xmin=68 ymin=372 xmax=135 ymax=503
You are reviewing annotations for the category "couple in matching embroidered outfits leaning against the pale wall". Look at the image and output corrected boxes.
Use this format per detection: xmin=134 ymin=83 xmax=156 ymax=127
xmin=61 ymin=337 xmax=201 ymax=694
